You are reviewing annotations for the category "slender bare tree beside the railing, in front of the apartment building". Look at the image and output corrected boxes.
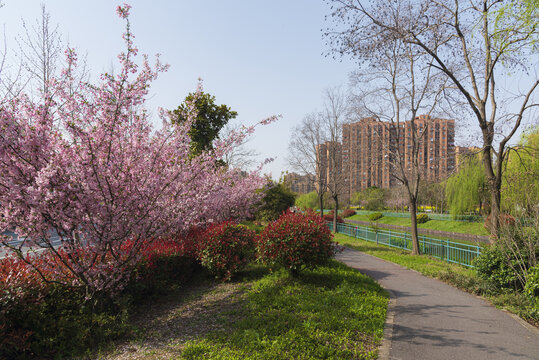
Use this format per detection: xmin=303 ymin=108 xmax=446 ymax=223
xmin=352 ymin=37 xmax=450 ymax=254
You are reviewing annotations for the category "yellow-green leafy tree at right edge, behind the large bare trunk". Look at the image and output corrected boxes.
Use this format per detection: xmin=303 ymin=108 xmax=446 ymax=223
xmin=502 ymin=127 xmax=539 ymax=216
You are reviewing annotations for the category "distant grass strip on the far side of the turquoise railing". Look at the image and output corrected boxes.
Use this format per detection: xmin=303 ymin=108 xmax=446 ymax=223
xmin=346 ymin=214 xmax=488 ymax=236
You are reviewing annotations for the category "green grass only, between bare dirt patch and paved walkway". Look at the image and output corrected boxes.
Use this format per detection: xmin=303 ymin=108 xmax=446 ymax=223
xmin=182 ymin=261 xmax=388 ymax=359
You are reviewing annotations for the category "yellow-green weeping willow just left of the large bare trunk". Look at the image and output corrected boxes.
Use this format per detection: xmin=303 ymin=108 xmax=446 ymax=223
xmin=445 ymin=154 xmax=489 ymax=216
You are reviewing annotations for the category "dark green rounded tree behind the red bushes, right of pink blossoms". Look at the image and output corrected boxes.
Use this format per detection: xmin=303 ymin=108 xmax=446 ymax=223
xmin=256 ymin=181 xmax=296 ymax=221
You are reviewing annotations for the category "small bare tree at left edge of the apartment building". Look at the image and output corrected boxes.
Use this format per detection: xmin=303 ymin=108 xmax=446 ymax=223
xmin=287 ymin=112 xmax=327 ymax=216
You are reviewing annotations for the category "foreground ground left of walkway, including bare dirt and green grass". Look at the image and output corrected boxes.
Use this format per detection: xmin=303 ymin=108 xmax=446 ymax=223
xmin=100 ymin=261 xmax=388 ymax=359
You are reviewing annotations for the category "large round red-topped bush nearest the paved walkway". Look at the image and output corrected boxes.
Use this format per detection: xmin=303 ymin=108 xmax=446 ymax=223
xmin=258 ymin=211 xmax=335 ymax=276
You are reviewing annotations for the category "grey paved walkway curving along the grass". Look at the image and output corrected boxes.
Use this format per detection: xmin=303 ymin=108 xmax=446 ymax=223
xmin=337 ymin=249 xmax=539 ymax=360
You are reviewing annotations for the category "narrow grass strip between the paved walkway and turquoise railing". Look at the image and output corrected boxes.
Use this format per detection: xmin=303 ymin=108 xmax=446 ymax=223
xmin=335 ymin=234 xmax=539 ymax=327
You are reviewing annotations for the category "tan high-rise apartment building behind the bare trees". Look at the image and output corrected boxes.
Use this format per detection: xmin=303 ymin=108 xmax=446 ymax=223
xmin=342 ymin=115 xmax=455 ymax=195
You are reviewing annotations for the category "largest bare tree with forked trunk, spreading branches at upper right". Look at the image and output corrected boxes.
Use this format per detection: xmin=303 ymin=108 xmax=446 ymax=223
xmin=326 ymin=0 xmax=539 ymax=233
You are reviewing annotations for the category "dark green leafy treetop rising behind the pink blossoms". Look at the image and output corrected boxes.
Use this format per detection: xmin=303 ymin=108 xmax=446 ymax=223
xmin=172 ymin=92 xmax=238 ymax=155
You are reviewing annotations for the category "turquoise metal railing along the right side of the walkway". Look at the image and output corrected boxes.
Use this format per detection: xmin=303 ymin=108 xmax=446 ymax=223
xmin=327 ymin=222 xmax=481 ymax=267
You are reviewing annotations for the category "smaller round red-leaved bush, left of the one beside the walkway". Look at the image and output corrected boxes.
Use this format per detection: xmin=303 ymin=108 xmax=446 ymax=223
xmin=198 ymin=221 xmax=256 ymax=280
